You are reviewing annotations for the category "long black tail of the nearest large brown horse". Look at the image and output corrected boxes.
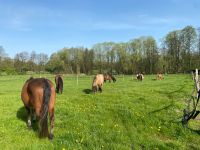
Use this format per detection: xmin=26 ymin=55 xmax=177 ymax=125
xmin=40 ymin=79 xmax=51 ymax=137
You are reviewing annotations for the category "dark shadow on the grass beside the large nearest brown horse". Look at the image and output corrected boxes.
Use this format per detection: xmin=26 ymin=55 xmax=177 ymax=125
xmin=16 ymin=107 xmax=39 ymax=131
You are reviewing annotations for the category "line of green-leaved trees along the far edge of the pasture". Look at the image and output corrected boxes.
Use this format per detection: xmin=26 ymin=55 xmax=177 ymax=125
xmin=0 ymin=26 xmax=200 ymax=74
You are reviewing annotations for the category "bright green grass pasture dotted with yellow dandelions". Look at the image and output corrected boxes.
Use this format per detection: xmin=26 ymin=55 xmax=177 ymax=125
xmin=0 ymin=75 xmax=200 ymax=150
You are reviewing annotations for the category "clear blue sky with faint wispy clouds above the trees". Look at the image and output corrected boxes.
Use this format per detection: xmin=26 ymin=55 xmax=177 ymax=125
xmin=0 ymin=0 xmax=200 ymax=57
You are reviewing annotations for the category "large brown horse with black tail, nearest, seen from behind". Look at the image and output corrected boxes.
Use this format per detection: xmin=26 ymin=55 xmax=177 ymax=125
xmin=21 ymin=78 xmax=56 ymax=139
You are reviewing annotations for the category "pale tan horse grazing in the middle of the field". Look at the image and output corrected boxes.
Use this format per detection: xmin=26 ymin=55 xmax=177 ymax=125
xmin=92 ymin=74 xmax=104 ymax=93
